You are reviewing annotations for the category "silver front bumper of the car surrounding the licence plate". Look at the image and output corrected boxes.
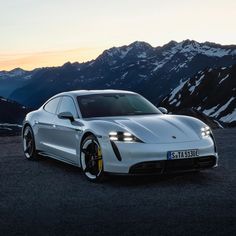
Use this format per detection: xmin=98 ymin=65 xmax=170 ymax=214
xmin=101 ymin=137 xmax=218 ymax=174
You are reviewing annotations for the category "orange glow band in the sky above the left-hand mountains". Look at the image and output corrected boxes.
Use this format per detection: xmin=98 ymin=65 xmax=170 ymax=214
xmin=0 ymin=48 xmax=103 ymax=71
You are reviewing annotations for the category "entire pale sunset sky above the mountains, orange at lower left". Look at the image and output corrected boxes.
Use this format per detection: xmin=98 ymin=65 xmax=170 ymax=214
xmin=0 ymin=0 xmax=236 ymax=70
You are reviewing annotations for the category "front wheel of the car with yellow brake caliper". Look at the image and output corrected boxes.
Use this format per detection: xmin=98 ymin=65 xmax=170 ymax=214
xmin=80 ymin=135 xmax=105 ymax=183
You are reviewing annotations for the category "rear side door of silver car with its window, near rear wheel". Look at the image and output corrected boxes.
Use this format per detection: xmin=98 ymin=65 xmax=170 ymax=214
xmin=35 ymin=97 xmax=61 ymax=154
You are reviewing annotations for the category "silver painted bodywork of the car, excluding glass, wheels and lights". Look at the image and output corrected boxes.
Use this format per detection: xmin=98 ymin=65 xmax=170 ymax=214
xmin=24 ymin=90 xmax=218 ymax=173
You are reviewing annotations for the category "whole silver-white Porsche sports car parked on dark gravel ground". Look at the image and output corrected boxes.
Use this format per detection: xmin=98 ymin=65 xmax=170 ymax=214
xmin=22 ymin=90 xmax=218 ymax=182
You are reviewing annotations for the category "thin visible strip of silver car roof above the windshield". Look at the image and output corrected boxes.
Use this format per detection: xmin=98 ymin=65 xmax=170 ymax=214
xmin=56 ymin=89 xmax=135 ymax=96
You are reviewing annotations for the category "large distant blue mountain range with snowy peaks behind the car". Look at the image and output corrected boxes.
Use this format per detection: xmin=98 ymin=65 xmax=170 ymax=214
xmin=0 ymin=40 xmax=236 ymax=107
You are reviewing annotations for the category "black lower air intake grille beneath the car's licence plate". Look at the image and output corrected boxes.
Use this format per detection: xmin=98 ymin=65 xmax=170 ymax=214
xmin=129 ymin=156 xmax=216 ymax=174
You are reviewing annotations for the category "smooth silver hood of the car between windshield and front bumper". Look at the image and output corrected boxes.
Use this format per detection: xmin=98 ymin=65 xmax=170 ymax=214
xmin=92 ymin=115 xmax=204 ymax=143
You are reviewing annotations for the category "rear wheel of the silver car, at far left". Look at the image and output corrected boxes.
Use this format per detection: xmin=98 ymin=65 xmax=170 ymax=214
xmin=23 ymin=125 xmax=38 ymax=160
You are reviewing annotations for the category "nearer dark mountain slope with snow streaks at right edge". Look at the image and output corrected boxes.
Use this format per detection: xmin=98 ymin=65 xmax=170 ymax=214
xmin=160 ymin=64 xmax=236 ymax=126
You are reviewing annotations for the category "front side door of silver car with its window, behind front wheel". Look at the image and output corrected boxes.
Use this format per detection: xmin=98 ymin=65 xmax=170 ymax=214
xmin=53 ymin=96 xmax=80 ymax=164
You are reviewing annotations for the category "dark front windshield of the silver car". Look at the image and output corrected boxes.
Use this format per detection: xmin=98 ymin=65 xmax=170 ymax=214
xmin=77 ymin=93 xmax=162 ymax=118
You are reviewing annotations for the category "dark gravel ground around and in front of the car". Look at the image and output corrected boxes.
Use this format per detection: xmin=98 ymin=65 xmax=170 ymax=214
xmin=0 ymin=129 xmax=236 ymax=235
